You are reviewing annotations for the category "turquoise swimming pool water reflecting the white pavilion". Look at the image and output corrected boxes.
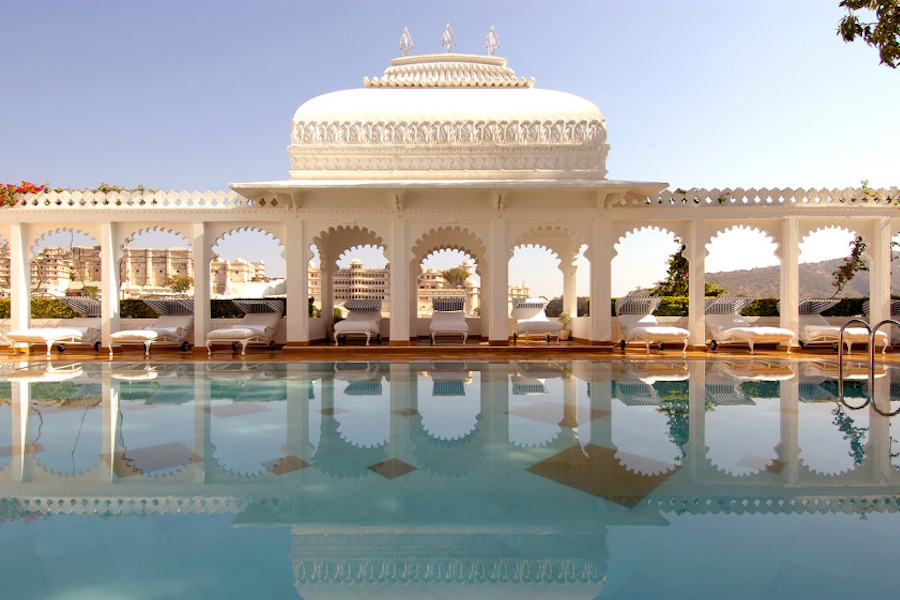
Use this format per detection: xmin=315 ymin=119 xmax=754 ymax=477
xmin=0 ymin=357 xmax=900 ymax=600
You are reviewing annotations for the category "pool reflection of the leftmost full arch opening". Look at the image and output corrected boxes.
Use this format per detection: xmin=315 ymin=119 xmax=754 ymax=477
xmin=28 ymin=383 xmax=103 ymax=477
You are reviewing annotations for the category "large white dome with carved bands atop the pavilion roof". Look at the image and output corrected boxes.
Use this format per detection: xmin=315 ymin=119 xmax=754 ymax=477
xmin=288 ymin=54 xmax=609 ymax=180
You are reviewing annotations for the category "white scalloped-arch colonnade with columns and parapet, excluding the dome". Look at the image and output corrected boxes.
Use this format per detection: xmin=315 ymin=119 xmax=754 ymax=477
xmin=0 ymin=188 xmax=900 ymax=348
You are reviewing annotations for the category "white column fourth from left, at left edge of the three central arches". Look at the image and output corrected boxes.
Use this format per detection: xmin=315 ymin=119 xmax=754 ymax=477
xmin=284 ymin=216 xmax=309 ymax=348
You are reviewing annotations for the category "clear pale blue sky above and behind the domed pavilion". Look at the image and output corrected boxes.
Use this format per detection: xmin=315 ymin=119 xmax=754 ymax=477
xmin=0 ymin=0 xmax=900 ymax=294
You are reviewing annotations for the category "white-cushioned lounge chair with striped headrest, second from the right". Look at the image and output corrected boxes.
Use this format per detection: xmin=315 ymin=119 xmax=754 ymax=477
xmin=706 ymin=296 xmax=796 ymax=354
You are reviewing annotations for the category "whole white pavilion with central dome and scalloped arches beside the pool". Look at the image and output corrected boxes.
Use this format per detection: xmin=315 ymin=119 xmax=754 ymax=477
xmin=0 ymin=31 xmax=900 ymax=349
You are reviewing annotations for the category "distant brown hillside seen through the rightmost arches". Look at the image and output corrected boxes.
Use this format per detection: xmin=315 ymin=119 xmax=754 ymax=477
xmin=706 ymin=258 xmax=900 ymax=298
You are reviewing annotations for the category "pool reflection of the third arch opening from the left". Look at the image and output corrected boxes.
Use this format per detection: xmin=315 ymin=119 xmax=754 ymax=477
xmin=209 ymin=398 xmax=287 ymax=477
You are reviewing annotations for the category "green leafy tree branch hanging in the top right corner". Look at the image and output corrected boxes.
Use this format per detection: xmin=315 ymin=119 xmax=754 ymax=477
xmin=838 ymin=0 xmax=900 ymax=69
